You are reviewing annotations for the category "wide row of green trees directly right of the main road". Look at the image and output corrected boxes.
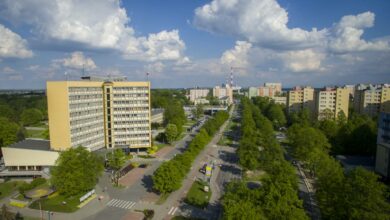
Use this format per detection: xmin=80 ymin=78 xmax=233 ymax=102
xmin=222 ymin=98 xmax=308 ymax=219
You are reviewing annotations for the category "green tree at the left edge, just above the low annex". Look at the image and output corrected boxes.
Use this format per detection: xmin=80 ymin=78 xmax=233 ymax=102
xmin=0 ymin=117 xmax=20 ymax=147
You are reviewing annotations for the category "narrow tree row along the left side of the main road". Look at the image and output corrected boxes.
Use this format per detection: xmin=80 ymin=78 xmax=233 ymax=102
xmin=152 ymin=111 xmax=229 ymax=193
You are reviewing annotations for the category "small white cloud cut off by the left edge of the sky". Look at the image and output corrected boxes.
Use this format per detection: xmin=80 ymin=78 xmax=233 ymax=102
xmin=0 ymin=24 xmax=33 ymax=58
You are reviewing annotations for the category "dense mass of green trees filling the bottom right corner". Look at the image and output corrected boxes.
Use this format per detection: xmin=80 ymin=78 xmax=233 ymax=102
xmin=287 ymin=117 xmax=390 ymax=219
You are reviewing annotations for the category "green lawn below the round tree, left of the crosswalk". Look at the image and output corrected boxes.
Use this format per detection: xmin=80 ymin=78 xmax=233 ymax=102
xmin=30 ymin=192 xmax=82 ymax=212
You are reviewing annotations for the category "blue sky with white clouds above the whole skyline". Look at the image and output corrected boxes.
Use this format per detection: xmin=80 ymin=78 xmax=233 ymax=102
xmin=0 ymin=0 xmax=390 ymax=89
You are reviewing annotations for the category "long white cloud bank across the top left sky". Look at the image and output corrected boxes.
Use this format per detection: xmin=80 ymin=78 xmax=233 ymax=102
xmin=0 ymin=0 xmax=185 ymax=61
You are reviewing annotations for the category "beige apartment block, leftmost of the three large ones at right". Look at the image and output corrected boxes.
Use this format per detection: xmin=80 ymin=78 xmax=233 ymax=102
xmin=287 ymin=86 xmax=315 ymax=113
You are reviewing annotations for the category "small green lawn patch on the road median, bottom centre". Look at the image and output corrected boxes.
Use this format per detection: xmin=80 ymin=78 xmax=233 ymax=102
xmin=185 ymin=181 xmax=211 ymax=208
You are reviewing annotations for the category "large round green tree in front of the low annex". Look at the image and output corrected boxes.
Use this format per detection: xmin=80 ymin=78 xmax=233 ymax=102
xmin=50 ymin=146 xmax=104 ymax=196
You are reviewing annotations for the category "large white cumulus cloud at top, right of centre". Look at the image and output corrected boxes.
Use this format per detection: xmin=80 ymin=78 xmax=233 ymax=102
xmin=194 ymin=0 xmax=326 ymax=48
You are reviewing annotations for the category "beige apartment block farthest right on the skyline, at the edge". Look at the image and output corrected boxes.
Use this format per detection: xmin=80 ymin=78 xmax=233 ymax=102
xmin=354 ymin=84 xmax=390 ymax=117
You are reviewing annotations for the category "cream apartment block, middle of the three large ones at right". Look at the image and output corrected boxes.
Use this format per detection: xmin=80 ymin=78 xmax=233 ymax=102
xmin=316 ymin=87 xmax=350 ymax=119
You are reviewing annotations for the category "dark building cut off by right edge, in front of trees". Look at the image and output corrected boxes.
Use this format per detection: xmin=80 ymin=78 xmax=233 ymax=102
xmin=375 ymin=112 xmax=390 ymax=179
